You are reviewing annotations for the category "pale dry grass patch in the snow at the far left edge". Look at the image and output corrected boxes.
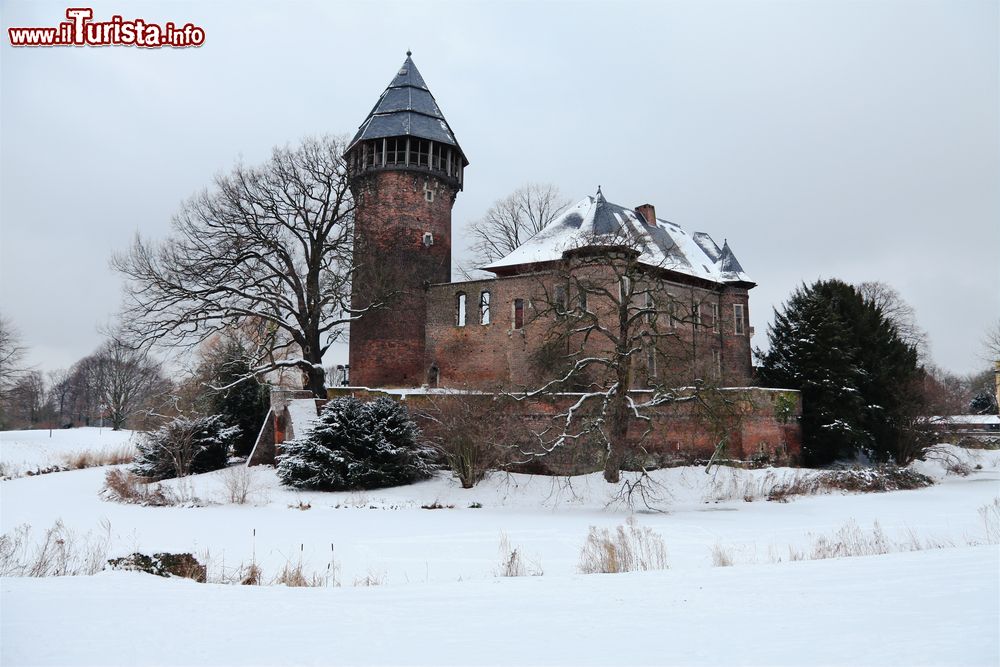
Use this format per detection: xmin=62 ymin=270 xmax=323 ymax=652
xmin=0 ymin=520 xmax=111 ymax=577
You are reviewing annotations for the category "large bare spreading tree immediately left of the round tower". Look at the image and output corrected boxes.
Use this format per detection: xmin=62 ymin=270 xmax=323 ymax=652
xmin=112 ymin=137 xmax=364 ymax=395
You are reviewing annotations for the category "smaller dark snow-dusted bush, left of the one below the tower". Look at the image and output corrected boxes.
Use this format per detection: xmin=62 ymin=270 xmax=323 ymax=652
xmin=132 ymin=416 xmax=240 ymax=481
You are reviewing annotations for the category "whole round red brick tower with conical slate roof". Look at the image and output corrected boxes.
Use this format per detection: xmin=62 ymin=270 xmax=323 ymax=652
xmin=345 ymin=52 xmax=469 ymax=387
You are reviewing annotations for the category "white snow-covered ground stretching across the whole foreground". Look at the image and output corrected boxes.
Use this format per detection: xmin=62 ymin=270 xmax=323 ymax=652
xmin=0 ymin=429 xmax=1000 ymax=665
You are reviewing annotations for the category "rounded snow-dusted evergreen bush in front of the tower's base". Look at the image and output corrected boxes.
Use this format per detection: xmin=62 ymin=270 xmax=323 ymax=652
xmin=277 ymin=398 xmax=434 ymax=491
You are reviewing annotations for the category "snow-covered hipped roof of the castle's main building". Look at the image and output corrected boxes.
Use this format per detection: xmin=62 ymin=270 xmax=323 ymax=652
xmin=482 ymin=188 xmax=754 ymax=286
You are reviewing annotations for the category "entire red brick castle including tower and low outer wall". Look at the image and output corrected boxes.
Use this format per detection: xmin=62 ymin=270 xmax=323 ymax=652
xmin=250 ymin=52 xmax=801 ymax=474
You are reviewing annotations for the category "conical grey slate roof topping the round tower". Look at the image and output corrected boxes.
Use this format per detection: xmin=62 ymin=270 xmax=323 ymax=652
xmin=347 ymin=51 xmax=469 ymax=164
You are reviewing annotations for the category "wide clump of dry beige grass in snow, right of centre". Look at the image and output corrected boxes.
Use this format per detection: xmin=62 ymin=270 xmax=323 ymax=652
xmin=579 ymin=516 xmax=668 ymax=574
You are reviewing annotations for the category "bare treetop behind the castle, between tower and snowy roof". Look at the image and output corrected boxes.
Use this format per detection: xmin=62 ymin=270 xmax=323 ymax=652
xmin=469 ymin=183 xmax=570 ymax=274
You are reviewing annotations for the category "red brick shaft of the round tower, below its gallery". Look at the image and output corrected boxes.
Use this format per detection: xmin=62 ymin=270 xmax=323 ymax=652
xmin=350 ymin=171 xmax=457 ymax=387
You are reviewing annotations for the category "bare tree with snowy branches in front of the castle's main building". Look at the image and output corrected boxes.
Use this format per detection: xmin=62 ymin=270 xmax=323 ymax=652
xmin=513 ymin=227 xmax=725 ymax=483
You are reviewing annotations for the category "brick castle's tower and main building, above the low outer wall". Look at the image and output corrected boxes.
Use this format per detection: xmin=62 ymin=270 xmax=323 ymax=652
xmin=345 ymin=52 xmax=754 ymax=389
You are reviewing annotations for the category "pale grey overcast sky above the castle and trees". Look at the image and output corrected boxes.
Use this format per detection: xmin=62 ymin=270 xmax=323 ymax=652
xmin=0 ymin=0 xmax=1000 ymax=373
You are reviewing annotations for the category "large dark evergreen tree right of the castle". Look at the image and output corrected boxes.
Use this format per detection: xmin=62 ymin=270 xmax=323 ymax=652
xmin=757 ymin=280 xmax=923 ymax=465
